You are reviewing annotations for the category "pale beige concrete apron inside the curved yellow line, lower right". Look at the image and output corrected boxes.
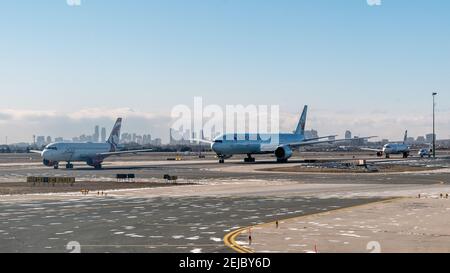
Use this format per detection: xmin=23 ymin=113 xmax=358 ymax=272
xmin=238 ymin=196 xmax=450 ymax=253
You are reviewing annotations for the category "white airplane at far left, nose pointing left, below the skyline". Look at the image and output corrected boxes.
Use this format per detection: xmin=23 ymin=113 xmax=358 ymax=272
xmin=30 ymin=118 xmax=152 ymax=169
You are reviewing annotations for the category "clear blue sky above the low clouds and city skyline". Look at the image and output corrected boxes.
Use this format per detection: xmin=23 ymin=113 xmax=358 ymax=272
xmin=0 ymin=0 xmax=450 ymax=143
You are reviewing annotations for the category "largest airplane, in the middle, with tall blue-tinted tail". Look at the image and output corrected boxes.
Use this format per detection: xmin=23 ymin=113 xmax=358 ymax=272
xmin=193 ymin=105 xmax=372 ymax=163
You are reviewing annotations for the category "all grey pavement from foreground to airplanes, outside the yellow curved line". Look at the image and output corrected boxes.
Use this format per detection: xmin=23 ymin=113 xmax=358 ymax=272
xmin=0 ymin=154 xmax=450 ymax=252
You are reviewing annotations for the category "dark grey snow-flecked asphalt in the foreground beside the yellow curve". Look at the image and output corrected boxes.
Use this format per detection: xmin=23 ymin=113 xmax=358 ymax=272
xmin=0 ymin=194 xmax=375 ymax=253
